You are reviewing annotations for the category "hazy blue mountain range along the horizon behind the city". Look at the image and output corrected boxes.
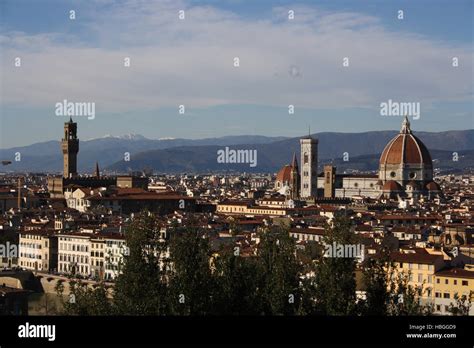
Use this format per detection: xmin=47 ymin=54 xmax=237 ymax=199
xmin=0 ymin=129 xmax=474 ymax=173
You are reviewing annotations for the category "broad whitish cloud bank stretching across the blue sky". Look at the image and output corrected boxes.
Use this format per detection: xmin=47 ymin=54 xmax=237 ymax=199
xmin=0 ymin=0 xmax=472 ymax=112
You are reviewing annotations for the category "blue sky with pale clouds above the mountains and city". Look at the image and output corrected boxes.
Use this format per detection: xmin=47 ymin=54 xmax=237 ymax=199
xmin=0 ymin=0 xmax=474 ymax=148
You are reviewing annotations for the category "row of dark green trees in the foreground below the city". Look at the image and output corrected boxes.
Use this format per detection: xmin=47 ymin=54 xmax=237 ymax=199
xmin=57 ymin=213 xmax=466 ymax=315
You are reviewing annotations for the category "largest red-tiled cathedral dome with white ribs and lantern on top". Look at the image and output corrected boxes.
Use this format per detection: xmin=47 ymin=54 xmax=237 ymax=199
xmin=380 ymin=118 xmax=432 ymax=166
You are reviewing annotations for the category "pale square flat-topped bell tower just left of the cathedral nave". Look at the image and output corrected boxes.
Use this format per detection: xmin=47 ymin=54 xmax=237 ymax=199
xmin=300 ymin=135 xmax=318 ymax=198
